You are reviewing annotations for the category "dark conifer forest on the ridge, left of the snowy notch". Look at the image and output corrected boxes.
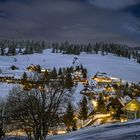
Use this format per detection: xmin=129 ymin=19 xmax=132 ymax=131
xmin=0 ymin=40 xmax=50 ymax=56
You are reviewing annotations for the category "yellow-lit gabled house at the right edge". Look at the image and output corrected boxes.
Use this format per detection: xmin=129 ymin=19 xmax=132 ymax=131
xmin=123 ymin=98 xmax=140 ymax=119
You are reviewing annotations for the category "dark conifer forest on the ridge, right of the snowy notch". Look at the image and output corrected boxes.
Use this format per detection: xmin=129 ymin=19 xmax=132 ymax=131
xmin=52 ymin=42 xmax=140 ymax=63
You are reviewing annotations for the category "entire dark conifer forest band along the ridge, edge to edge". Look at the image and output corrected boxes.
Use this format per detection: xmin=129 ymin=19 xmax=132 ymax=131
xmin=0 ymin=40 xmax=140 ymax=63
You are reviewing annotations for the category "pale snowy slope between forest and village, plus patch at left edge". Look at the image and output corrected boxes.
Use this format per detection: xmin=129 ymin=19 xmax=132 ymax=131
xmin=0 ymin=50 xmax=140 ymax=95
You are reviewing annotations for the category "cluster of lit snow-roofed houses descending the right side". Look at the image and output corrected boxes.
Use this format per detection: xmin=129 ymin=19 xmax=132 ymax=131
xmin=80 ymin=72 xmax=140 ymax=122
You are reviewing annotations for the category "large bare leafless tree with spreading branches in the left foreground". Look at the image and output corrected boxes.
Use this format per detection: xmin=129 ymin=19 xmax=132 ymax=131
xmin=6 ymin=85 xmax=70 ymax=140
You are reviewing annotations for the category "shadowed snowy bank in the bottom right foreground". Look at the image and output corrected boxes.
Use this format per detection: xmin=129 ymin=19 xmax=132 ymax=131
xmin=47 ymin=120 xmax=140 ymax=140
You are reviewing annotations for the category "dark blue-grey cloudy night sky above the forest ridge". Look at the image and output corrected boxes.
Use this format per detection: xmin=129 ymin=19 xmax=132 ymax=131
xmin=0 ymin=0 xmax=140 ymax=45
